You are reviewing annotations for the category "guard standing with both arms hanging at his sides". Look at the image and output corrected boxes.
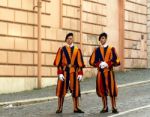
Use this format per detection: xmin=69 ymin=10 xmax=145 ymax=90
xmin=54 ymin=33 xmax=85 ymax=113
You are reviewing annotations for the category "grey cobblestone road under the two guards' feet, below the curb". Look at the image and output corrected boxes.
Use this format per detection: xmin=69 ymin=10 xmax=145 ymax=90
xmin=0 ymin=80 xmax=150 ymax=117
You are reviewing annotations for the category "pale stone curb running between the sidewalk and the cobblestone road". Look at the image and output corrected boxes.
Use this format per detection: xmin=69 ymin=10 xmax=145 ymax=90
xmin=0 ymin=80 xmax=150 ymax=107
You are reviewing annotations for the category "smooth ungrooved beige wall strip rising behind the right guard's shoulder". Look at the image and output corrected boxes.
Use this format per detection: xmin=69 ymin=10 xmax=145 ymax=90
xmin=106 ymin=0 xmax=119 ymax=49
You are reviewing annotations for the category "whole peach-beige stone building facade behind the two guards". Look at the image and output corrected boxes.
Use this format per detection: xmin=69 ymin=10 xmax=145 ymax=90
xmin=0 ymin=0 xmax=150 ymax=93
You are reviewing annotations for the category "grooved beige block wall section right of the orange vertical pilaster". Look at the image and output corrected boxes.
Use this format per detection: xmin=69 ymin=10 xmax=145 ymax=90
xmin=124 ymin=0 xmax=147 ymax=69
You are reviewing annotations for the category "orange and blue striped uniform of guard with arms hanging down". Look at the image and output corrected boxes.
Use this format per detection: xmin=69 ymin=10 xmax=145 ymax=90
xmin=54 ymin=46 xmax=85 ymax=97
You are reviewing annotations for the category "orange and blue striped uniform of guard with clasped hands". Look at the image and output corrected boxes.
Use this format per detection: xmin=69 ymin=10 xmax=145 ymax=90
xmin=89 ymin=46 xmax=120 ymax=97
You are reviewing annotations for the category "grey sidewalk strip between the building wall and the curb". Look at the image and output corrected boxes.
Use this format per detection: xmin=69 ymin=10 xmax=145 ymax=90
xmin=0 ymin=69 xmax=150 ymax=103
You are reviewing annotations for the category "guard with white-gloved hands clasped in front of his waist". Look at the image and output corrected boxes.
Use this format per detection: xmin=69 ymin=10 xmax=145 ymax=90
xmin=89 ymin=33 xmax=120 ymax=113
